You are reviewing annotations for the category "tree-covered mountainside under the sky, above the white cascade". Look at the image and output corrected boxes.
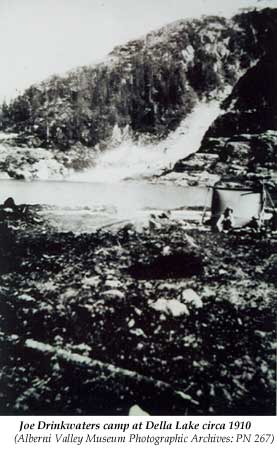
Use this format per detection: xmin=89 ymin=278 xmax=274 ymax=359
xmin=1 ymin=9 xmax=277 ymax=155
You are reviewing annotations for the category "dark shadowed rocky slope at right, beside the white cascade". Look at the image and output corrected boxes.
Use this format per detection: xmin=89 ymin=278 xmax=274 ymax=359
xmin=172 ymin=48 xmax=277 ymax=181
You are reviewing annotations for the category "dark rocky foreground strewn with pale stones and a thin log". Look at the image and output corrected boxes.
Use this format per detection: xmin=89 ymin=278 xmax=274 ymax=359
xmin=0 ymin=211 xmax=277 ymax=415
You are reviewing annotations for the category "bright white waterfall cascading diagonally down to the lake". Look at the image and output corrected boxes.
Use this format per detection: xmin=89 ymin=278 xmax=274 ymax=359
xmin=70 ymin=100 xmax=220 ymax=182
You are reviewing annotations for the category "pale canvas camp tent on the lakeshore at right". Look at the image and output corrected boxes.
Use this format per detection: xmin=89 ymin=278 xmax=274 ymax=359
xmin=211 ymin=186 xmax=265 ymax=228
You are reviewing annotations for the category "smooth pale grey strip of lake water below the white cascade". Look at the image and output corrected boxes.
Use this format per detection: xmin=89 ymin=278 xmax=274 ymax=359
xmin=0 ymin=180 xmax=209 ymax=211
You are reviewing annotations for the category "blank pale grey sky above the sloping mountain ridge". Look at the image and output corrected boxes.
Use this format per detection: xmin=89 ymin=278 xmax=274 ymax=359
xmin=0 ymin=0 xmax=277 ymax=102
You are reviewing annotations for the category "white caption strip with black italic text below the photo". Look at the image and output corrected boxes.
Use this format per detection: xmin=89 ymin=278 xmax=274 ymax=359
xmin=1 ymin=416 xmax=277 ymax=450
